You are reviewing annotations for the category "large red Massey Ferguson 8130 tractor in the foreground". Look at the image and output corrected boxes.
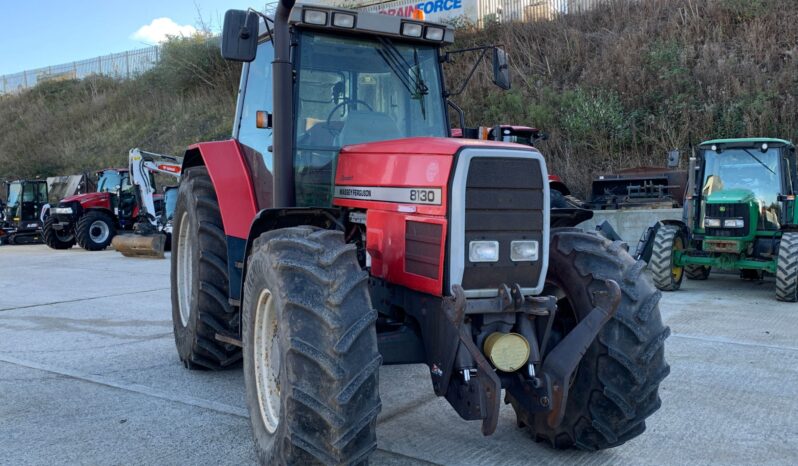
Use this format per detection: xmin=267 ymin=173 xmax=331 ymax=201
xmin=171 ymin=0 xmax=669 ymax=465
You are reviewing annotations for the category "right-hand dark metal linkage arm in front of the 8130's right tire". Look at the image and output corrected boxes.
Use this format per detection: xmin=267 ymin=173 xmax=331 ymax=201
xmin=542 ymin=280 xmax=621 ymax=428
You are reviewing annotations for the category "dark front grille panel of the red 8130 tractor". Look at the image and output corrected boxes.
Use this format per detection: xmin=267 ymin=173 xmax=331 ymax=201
xmin=462 ymin=157 xmax=546 ymax=290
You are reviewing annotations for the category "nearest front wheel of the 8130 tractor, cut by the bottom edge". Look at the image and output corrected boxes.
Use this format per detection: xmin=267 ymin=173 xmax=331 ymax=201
xmin=242 ymin=227 xmax=382 ymax=465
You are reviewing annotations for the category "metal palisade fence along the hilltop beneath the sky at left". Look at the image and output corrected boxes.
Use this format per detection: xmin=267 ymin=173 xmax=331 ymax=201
xmin=0 ymin=46 xmax=160 ymax=94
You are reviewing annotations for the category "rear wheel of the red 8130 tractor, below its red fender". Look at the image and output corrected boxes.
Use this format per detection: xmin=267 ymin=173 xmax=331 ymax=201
xmin=171 ymin=167 xmax=241 ymax=370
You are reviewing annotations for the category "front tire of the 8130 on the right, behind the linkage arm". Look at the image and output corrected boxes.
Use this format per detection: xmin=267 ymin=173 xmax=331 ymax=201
xmin=507 ymin=229 xmax=670 ymax=451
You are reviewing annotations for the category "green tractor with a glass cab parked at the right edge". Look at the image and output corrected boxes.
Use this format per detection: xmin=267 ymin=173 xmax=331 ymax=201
xmin=648 ymin=138 xmax=798 ymax=301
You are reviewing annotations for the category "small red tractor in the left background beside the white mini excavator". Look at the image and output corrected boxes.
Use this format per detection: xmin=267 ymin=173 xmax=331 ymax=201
xmin=43 ymin=168 xmax=161 ymax=251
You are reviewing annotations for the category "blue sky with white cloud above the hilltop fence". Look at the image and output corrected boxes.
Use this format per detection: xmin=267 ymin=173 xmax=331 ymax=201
xmin=0 ymin=0 xmax=265 ymax=75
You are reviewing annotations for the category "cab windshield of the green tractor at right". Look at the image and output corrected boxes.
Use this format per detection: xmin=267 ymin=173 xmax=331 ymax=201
xmin=702 ymin=147 xmax=783 ymax=228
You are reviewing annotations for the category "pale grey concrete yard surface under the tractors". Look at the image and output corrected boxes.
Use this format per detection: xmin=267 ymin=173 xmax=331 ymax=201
xmin=0 ymin=245 xmax=798 ymax=465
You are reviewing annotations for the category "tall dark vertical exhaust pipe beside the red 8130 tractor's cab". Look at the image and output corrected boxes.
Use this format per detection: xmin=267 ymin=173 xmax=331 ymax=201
xmin=272 ymin=0 xmax=296 ymax=208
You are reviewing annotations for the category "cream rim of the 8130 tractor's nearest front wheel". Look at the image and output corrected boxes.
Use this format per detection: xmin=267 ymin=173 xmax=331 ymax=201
xmin=252 ymin=289 xmax=280 ymax=434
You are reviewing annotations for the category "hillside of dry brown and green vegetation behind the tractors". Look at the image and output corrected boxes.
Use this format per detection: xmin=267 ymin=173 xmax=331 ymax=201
xmin=0 ymin=0 xmax=798 ymax=196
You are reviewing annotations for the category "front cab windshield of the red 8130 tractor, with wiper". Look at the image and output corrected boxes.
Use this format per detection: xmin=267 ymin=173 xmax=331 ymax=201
xmin=294 ymin=31 xmax=447 ymax=206
